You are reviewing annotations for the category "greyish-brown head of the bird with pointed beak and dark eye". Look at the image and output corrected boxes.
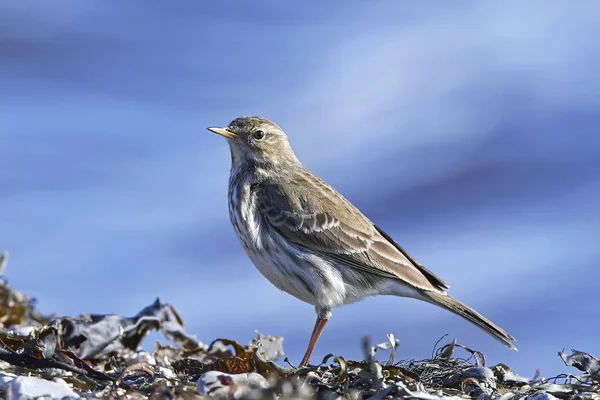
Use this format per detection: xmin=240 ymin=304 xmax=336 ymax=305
xmin=208 ymin=117 xmax=298 ymax=166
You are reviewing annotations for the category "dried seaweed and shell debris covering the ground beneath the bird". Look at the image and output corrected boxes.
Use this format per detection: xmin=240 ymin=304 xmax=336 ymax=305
xmin=0 ymin=255 xmax=600 ymax=400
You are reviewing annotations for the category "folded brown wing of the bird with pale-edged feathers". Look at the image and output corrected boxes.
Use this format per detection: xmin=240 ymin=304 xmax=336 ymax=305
xmin=257 ymin=171 xmax=448 ymax=291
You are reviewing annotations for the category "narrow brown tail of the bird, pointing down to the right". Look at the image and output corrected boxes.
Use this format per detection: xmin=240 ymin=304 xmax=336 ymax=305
xmin=421 ymin=291 xmax=517 ymax=350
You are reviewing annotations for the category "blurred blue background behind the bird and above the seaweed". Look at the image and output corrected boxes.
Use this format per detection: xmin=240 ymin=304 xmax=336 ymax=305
xmin=0 ymin=0 xmax=600 ymax=376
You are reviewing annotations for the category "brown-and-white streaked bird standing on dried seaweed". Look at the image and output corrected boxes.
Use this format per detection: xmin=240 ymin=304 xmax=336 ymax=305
xmin=207 ymin=116 xmax=516 ymax=367
